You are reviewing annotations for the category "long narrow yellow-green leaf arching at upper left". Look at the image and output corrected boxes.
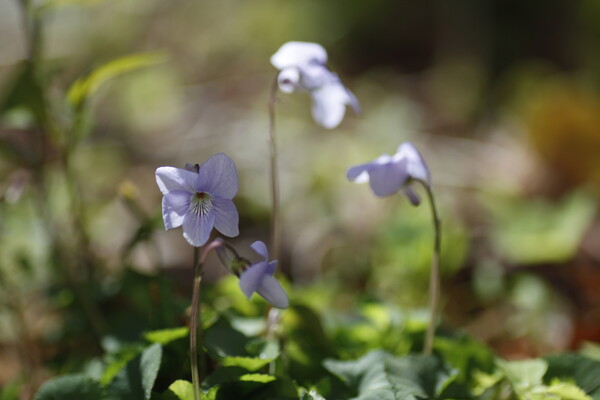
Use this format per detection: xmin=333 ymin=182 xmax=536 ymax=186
xmin=67 ymin=53 xmax=166 ymax=109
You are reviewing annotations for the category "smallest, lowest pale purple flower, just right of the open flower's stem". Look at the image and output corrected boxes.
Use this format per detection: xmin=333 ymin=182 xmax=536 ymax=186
xmin=240 ymin=241 xmax=290 ymax=308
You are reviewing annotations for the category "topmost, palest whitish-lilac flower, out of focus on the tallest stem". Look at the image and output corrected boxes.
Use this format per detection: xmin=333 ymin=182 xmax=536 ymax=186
xmin=271 ymin=42 xmax=360 ymax=129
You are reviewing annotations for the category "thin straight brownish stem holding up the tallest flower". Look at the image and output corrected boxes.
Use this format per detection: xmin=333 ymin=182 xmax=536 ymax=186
xmin=269 ymin=77 xmax=281 ymax=259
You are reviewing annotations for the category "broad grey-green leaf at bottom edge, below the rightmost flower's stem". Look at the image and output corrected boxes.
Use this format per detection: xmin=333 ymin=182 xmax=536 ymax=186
xmin=324 ymin=350 xmax=456 ymax=400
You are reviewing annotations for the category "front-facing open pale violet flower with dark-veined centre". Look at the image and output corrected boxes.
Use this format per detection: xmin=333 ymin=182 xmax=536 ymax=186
xmin=156 ymin=153 xmax=239 ymax=247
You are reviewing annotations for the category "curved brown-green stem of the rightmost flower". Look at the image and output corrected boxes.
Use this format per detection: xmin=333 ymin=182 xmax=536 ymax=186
xmin=419 ymin=181 xmax=442 ymax=355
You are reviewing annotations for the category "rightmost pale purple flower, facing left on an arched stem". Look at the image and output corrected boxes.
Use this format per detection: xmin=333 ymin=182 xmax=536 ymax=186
xmin=346 ymin=143 xmax=431 ymax=206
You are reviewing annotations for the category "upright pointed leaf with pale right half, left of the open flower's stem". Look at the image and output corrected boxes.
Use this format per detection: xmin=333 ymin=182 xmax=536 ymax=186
xmin=108 ymin=343 xmax=162 ymax=400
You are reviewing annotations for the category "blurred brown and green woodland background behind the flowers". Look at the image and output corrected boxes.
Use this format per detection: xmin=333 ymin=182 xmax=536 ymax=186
xmin=0 ymin=0 xmax=600 ymax=394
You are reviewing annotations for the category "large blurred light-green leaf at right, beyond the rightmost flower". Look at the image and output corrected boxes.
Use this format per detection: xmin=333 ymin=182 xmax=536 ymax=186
xmin=485 ymin=192 xmax=597 ymax=264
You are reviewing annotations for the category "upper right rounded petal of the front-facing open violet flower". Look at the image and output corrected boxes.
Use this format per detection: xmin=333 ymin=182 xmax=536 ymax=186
xmin=197 ymin=153 xmax=238 ymax=199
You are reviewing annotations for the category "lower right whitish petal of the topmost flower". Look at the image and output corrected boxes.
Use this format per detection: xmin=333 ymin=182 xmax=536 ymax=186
xmin=311 ymin=81 xmax=350 ymax=129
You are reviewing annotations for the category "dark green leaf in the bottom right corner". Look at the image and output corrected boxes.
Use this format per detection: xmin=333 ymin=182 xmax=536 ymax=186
xmin=544 ymin=354 xmax=600 ymax=400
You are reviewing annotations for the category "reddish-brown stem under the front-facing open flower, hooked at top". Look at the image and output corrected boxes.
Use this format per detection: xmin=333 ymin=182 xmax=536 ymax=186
xmin=190 ymin=239 xmax=223 ymax=400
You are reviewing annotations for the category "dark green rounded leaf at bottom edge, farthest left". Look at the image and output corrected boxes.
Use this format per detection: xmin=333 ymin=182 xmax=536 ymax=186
xmin=34 ymin=375 xmax=105 ymax=400
